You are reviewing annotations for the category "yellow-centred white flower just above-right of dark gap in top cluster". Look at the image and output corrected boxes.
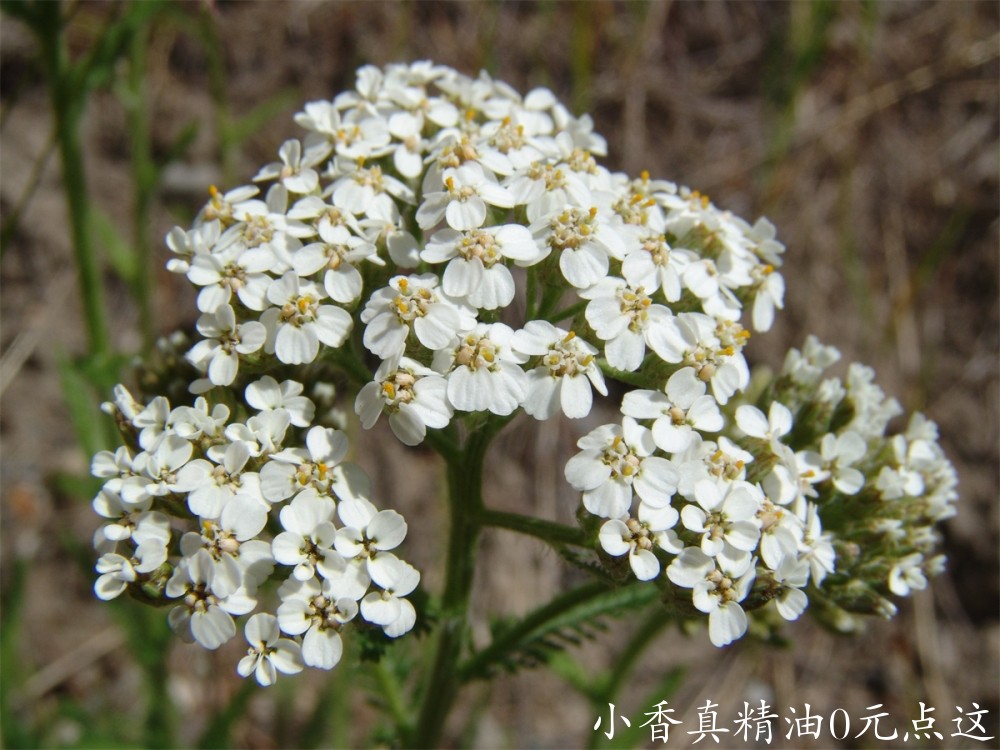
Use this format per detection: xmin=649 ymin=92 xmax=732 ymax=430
xmin=528 ymin=206 xmax=625 ymax=289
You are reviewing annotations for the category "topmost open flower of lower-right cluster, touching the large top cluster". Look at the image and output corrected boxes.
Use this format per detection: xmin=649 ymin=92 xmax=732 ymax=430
xmin=621 ymin=367 xmax=725 ymax=453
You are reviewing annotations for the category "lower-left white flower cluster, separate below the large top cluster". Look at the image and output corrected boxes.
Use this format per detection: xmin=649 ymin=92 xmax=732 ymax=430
xmin=92 ymin=376 xmax=420 ymax=685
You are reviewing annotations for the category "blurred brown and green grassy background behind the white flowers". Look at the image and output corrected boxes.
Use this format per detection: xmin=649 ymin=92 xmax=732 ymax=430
xmin=0 ymin=0 xmax=1000 ymax=748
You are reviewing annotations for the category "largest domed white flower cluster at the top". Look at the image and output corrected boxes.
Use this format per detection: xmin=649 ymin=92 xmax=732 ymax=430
xmin=168 ymin=63 xmax=784 ymax=445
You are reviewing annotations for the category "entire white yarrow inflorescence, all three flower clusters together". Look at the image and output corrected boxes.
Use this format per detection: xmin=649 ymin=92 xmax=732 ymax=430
xmin=93 ymin=62 xmax=957 ymax=685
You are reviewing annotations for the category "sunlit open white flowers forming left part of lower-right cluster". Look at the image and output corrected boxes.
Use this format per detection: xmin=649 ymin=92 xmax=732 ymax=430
xmin=566 ymin=367 xmax=836 ymax=646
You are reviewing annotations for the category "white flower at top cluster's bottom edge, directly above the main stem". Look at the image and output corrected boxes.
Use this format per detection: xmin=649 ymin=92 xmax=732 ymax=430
xmin=433 ymin=323 xmax=528 ymax=416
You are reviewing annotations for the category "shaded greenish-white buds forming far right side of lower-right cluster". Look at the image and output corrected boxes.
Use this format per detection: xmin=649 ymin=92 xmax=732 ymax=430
xmin=775 ymin=337 xmax=958 ymax=616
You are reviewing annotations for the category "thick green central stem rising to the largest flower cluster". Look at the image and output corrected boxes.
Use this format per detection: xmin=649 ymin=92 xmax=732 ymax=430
xmin=410 ymin=425 xmax=496 ymax=747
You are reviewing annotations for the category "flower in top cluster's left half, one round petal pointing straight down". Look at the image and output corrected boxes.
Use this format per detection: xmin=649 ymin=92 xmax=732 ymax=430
xmin=292 ymin=221 xmax=385 ymax=305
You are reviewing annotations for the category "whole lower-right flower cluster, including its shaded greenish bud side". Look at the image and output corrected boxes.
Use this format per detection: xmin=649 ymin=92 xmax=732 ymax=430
xmin=566 ymin=338 xmax=957 ymax=646
